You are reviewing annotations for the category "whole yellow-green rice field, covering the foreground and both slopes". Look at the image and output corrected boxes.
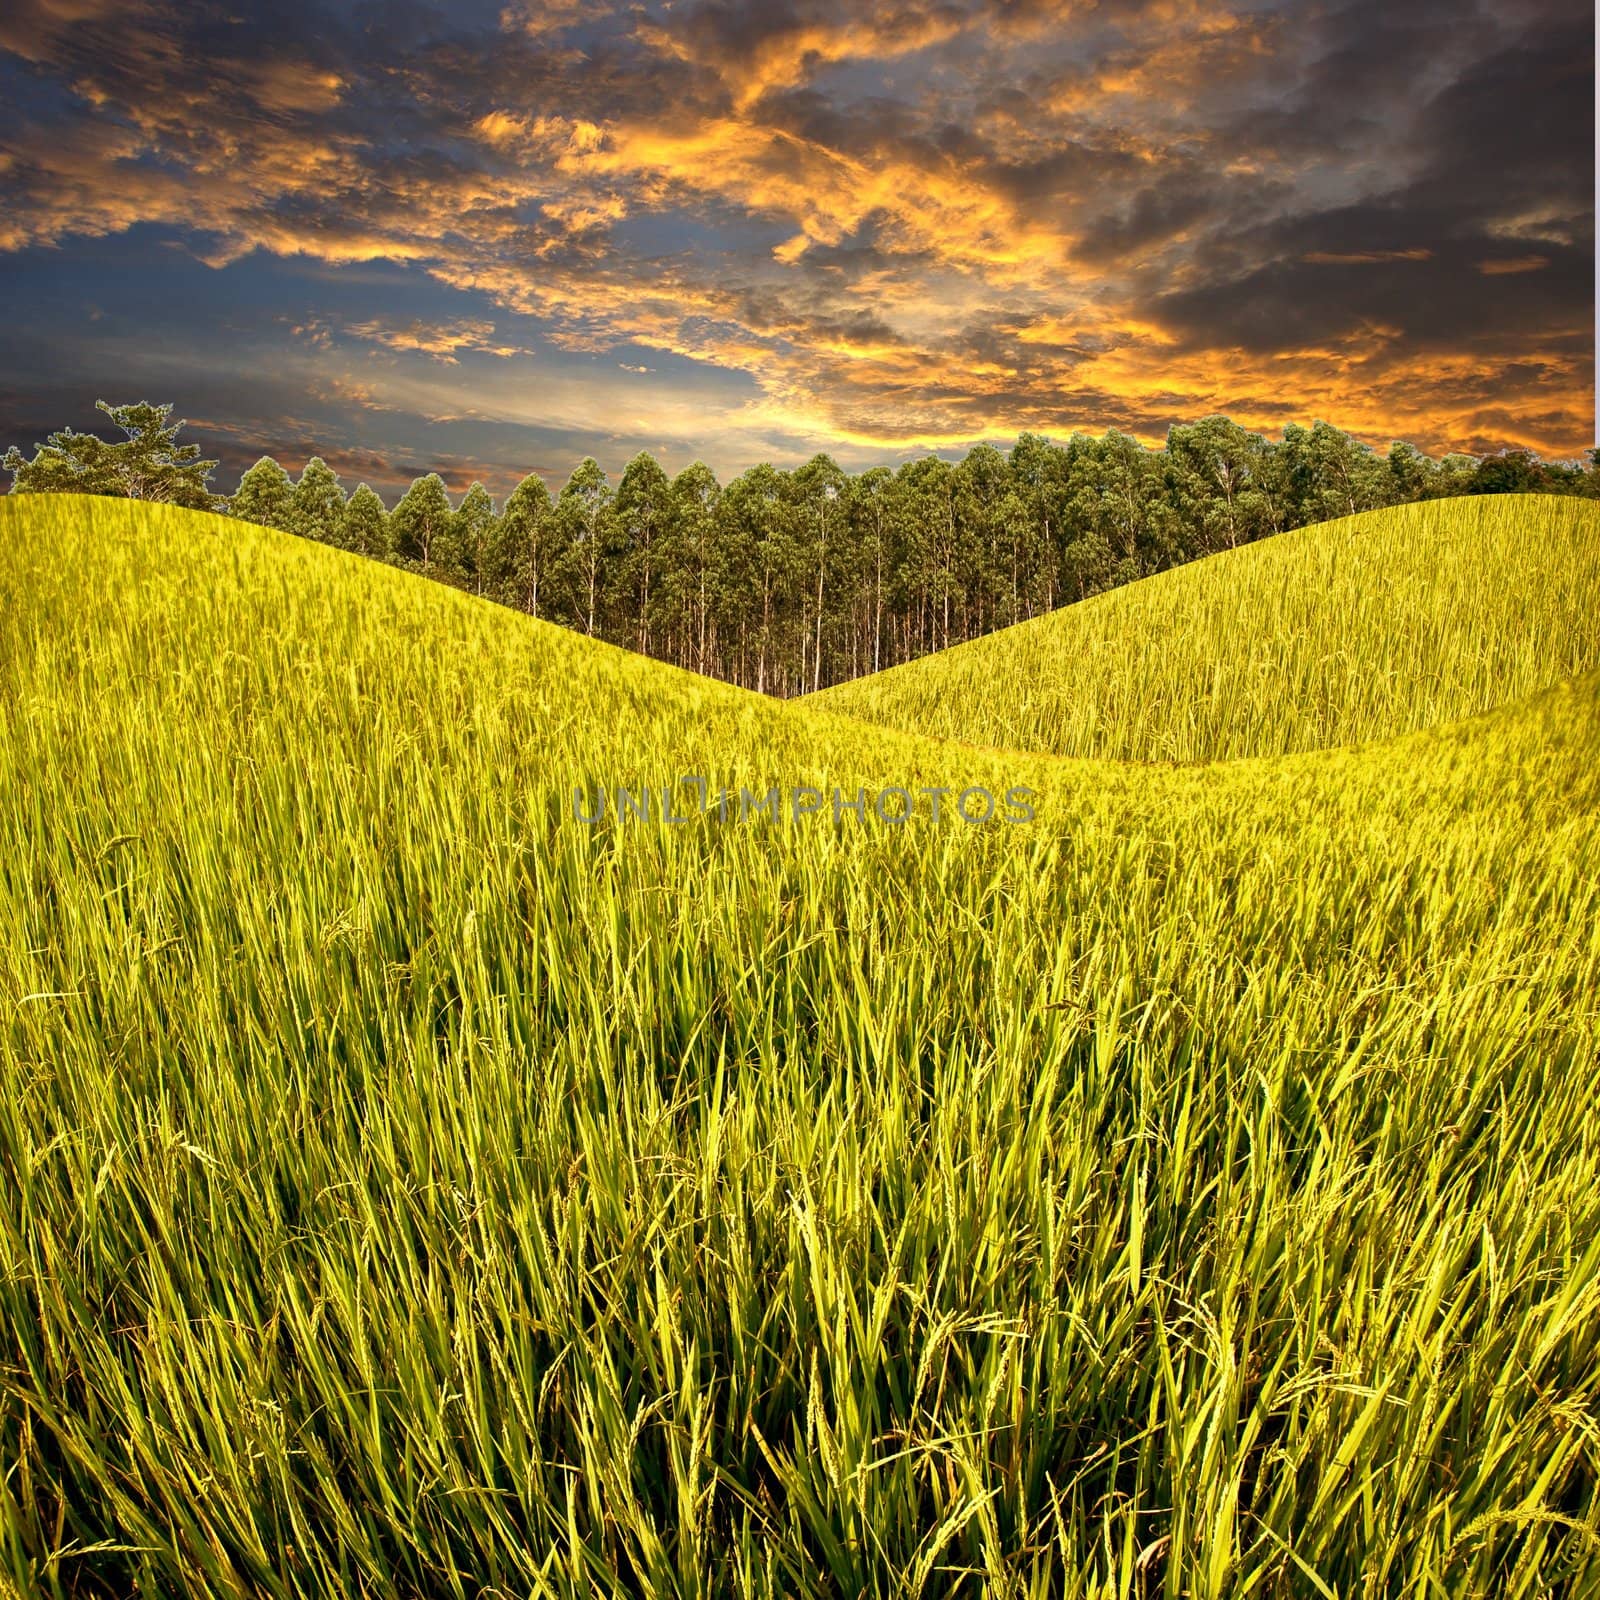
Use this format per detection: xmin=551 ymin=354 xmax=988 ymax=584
xmin=0 ymin=496 xmax=1600 ymax=1600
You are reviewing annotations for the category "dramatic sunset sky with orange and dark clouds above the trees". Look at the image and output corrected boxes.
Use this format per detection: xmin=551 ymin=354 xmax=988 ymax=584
xmin=0 ymin=0 xmax=1595 ymax=493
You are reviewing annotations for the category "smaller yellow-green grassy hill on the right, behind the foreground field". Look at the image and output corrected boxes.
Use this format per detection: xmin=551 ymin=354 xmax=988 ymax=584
xmin=810 ymin=494 xmax=1600 ymax=762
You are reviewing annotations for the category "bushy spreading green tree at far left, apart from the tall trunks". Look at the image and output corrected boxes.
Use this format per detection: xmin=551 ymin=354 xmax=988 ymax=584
xmin=3 ymin=400 xmax=222 ymax=510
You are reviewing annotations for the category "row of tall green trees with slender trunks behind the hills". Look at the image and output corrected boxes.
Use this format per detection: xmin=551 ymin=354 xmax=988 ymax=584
xmin=5 ymin=403 xmax=1600 ymax=696
